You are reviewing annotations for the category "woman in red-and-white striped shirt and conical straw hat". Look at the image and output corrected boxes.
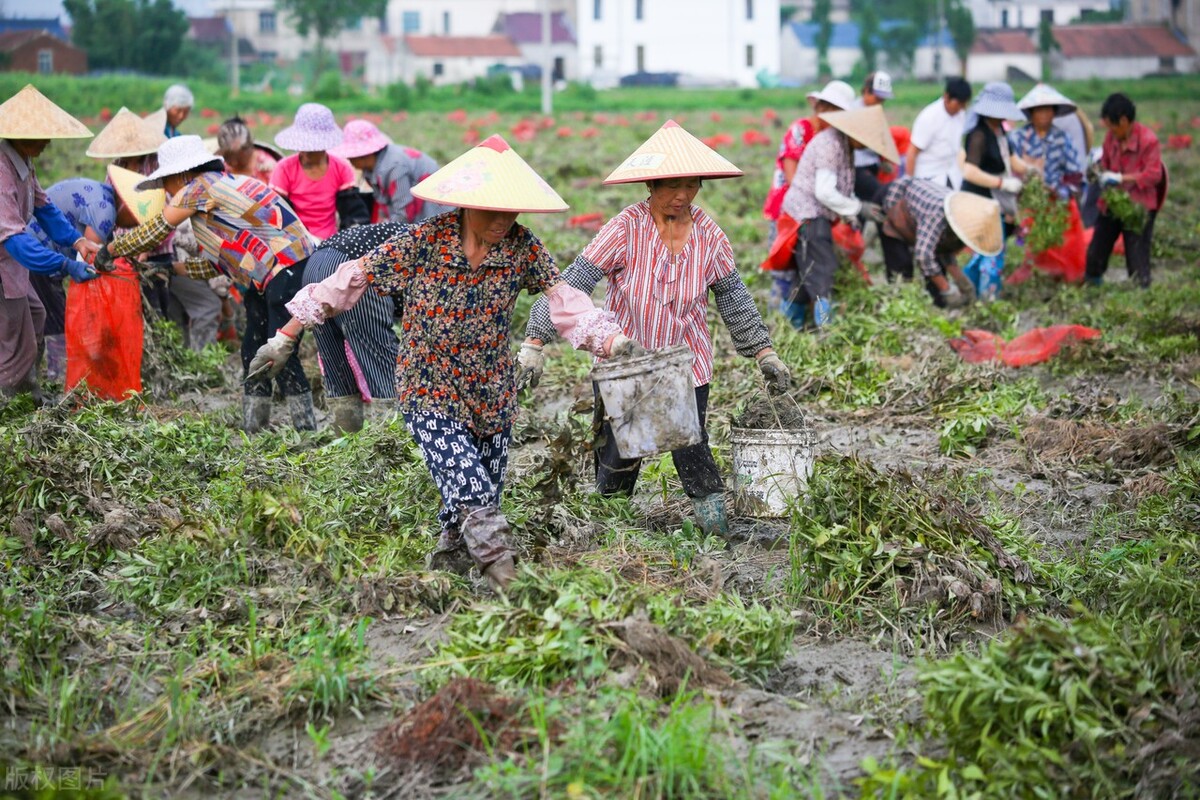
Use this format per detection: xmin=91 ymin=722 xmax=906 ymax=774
xmin=520 ymin=121 xmax=791 ymax=535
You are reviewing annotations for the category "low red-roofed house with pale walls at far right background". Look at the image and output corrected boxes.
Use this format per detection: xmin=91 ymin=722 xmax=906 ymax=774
xmin=1050 ymin=24 xmax=1196 ymax=80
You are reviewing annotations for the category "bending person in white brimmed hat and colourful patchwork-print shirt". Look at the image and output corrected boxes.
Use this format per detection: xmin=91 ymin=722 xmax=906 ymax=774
xmin=96 ymin=136 xmax=317 ymax=433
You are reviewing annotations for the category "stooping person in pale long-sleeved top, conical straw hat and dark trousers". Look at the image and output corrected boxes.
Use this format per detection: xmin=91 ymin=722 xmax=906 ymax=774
xmin=784 ymin=106 xmax=900 ymax=327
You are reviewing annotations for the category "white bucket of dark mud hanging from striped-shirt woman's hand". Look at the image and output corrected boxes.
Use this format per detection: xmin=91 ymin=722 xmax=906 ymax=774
xmin=730 ymin=427 xmax=812 ymax=517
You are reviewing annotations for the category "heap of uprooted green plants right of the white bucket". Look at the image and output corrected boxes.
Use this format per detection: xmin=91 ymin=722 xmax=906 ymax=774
xmin=787 ymin=456 xmax=1065 ymax=651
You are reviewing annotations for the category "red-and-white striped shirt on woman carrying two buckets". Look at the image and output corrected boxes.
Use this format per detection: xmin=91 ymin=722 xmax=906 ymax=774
xmin=580 ymin=200 xmax=736 ymax=386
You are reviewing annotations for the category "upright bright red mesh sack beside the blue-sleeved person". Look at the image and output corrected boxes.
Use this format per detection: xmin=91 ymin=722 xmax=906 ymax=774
xmin=65 ymin=258 xmax=143 ymax=401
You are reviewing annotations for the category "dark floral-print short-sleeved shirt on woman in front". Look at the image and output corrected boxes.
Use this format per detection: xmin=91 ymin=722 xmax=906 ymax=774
xmin=362 ymin=211 xmax=558 ymax=435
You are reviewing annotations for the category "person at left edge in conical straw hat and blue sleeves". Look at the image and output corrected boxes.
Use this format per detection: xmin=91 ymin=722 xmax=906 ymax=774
xmin=0 ymin=85 xmax=98 ymax=402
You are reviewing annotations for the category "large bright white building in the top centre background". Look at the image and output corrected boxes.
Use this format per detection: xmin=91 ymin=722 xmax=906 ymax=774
xmin=575 ymin=0 xmax=780 ymax=86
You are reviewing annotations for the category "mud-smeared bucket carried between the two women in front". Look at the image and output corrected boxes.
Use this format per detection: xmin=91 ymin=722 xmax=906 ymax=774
xmin=592 ymin=345 xmax=703 ymax=458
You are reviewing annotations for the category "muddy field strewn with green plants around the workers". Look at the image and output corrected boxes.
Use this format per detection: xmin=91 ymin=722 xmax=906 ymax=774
xmin=0 ymin=92 xmax=1200 ymax=799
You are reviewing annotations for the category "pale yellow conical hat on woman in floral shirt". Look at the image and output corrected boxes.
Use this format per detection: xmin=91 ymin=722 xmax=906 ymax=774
xmin=413 ymin=134 xmax=568 ymax=212
